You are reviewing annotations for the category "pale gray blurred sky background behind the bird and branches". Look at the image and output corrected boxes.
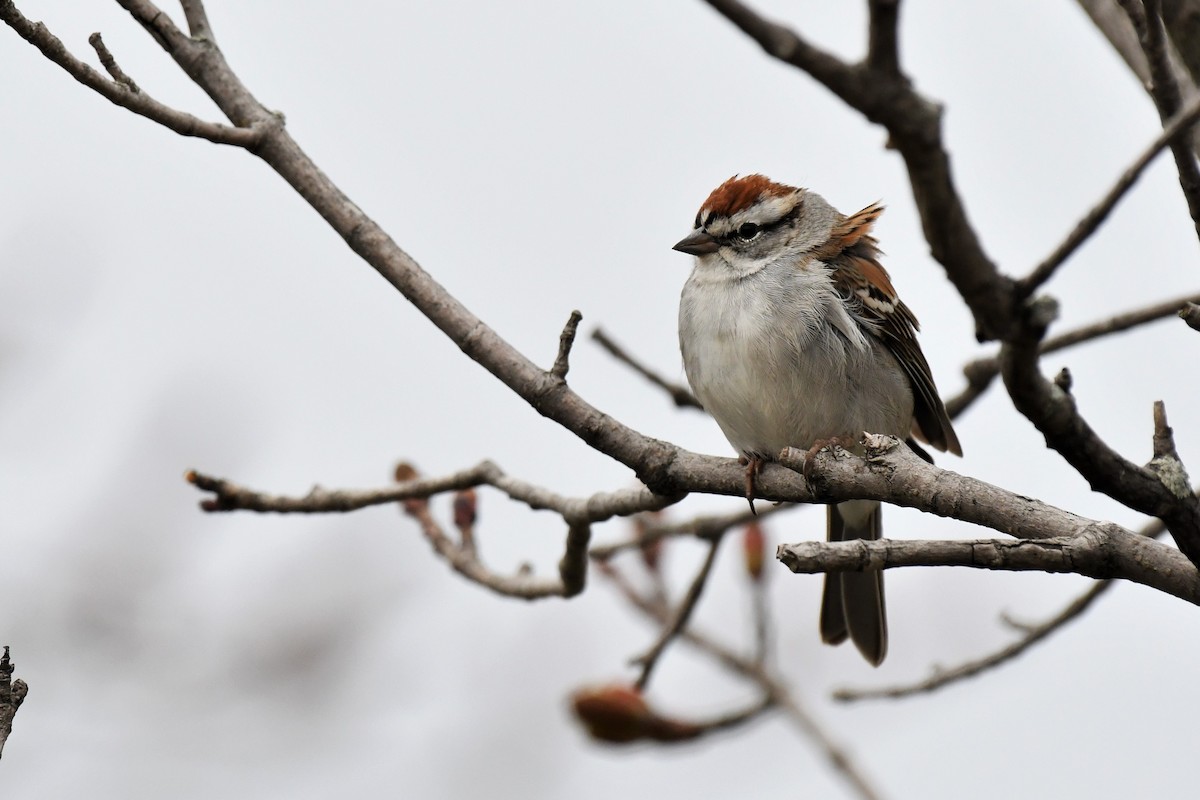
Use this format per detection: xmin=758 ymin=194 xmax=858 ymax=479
xmin=0 ymin=0 xmax=1200 ymax=800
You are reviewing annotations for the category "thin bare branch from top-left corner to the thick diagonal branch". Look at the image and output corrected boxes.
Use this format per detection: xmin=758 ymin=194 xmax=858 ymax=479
xmin=0 ymin=0 xmax=263 ymax=149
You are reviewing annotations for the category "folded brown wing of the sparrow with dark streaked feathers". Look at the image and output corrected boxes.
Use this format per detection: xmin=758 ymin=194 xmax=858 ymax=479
xmin=817 ymin=203 xmax=962 ymax=456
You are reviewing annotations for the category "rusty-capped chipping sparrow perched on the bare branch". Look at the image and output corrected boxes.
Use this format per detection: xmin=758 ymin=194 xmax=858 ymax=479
xmin=674 ymin=175 xmax=962 ymax=666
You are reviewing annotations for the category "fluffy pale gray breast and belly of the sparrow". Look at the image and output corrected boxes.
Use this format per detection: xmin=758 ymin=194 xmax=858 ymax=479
xmin=679 ymin=262 xmax=912 ymax=457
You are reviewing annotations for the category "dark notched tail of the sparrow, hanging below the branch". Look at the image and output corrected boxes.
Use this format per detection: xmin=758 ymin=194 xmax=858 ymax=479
xmin=821 ymin=500 xmax=888 ymax=667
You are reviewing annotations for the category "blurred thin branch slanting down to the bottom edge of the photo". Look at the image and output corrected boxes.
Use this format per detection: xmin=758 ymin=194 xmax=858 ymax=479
xmin=596 ymin=561 xmax=880 ymax=800
